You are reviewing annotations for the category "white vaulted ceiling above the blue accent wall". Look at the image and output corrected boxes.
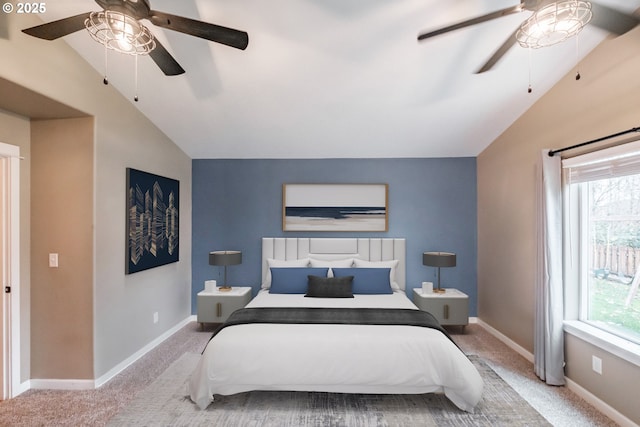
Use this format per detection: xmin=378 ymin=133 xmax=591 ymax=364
xmin=23 ymin=0 xmax=640 ymax=158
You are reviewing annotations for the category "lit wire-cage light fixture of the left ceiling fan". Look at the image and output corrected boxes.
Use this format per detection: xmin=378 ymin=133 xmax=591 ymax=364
xmin=84 ymin=10 xmax=156 ymax=55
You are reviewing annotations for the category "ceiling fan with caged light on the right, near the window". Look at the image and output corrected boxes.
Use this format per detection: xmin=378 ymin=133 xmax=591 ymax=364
xmin=418 ymin=0 xmax=640 ymax=74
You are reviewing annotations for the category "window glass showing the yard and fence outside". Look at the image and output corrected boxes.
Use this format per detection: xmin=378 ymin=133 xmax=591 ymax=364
xmin=580 ymin=174 xmax=640 ymax=343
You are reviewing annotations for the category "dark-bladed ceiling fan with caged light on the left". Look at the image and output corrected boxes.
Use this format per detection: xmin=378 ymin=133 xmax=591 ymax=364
xmin=22 ymin=0 xmax=249 ymax=76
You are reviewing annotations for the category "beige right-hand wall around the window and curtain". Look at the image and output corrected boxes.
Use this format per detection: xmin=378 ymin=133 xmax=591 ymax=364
xmin=478 ymin=28 xmax=640 ymax=422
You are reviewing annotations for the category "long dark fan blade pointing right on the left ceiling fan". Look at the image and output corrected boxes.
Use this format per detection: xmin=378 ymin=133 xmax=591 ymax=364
xmin=149 ymin=10 xmax=249 ymax=50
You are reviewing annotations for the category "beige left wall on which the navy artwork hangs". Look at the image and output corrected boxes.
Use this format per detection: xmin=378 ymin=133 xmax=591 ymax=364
xmin=0 ymin=14 xmax=191 ymax=379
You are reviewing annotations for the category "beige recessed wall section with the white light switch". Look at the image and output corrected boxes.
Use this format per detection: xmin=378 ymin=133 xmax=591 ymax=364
xmin=31 ymin=117 xmax=94 ymax=379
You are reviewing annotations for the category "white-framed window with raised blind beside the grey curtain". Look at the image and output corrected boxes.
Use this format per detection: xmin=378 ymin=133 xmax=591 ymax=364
xmin=563 ymin=143 xmax=640 ymax=344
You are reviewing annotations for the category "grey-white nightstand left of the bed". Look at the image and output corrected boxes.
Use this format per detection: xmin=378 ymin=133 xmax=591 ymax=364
xmin=196 ymin=286 xmax=251 ymax=328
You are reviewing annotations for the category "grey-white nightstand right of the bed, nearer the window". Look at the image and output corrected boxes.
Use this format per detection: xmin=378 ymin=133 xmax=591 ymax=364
xmin=413 ymin=288 xmax=469 ymax=330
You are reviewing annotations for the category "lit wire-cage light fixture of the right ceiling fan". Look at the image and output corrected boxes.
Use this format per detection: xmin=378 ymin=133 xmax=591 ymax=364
xmin=516 ymin=0 xmax=593 ymax=49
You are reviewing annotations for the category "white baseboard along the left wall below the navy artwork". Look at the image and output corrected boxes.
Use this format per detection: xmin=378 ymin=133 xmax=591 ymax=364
xmin=29 ymin=315 xmax=195 ymax=392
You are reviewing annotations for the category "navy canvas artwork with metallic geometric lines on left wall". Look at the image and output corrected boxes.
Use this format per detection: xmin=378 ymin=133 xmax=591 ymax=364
xmin=125 ymin=168 xmax=180 ymax=274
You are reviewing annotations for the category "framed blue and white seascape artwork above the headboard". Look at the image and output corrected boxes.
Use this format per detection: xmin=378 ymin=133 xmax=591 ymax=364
xmin=282 ymin=184 xmax=388 ymax=231
